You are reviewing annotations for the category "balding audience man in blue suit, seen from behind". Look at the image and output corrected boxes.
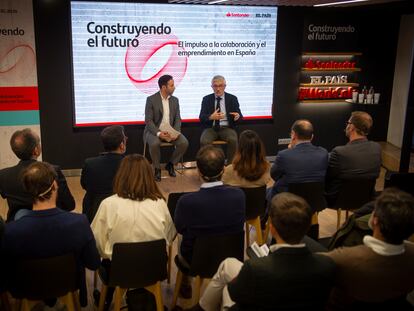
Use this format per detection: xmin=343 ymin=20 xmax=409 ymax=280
xmin=267 ymin=120 xmax=328 ymax=202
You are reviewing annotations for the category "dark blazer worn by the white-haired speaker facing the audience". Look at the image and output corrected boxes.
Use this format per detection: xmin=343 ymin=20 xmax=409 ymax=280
xmin=199 ymin=93 xmax=243 ymax=128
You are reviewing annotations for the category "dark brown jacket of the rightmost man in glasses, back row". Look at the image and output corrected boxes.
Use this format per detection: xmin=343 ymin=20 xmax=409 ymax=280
xmin=326 ymin=139 xmax=381 ymax=203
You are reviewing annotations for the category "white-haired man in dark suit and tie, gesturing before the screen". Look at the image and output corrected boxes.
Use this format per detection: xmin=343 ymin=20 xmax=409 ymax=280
xmin=199 ymin=76 xmax=242 ymax=163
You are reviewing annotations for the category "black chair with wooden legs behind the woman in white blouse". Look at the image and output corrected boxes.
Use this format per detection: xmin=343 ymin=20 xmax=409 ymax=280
xmin=98 ymin=240 xmax=167 ymax=311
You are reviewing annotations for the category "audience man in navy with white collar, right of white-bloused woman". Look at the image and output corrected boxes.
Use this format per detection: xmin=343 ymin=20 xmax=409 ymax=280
xmin=174 ymin=145 xmax=245 ymax=298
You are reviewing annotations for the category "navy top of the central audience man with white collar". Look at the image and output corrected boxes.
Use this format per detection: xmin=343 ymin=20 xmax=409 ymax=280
xmin=174 ymin=186 xmax=245 ymax=263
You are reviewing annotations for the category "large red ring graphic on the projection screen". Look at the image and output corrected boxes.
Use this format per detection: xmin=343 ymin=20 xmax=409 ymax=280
xmin=125 ymin=34 xmax=188 ymax=94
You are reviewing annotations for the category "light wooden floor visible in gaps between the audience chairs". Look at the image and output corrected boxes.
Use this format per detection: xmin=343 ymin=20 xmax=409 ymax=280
xmin=0 ymin=168 xmax=385 ymax=311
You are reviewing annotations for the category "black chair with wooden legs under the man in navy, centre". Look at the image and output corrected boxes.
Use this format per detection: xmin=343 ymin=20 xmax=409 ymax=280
xmin=171 ymin=232 xmax=244 ymax=309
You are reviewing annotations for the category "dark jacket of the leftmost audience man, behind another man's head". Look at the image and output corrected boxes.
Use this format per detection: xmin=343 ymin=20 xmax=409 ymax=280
xmin=0 ymin=159 xmax=75 ymax=221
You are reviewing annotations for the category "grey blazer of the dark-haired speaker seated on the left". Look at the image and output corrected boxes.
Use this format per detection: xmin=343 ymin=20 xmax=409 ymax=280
xmin=144 ymin=92 xmax=181 ymax=136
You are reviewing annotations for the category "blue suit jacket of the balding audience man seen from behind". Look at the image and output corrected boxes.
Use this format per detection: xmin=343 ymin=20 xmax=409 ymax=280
xmin=269 ymin=143 xmax=328 ymax=199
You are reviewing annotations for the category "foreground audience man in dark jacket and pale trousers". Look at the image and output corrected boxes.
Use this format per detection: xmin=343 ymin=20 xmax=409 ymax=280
xmin=190 ymin=192 xmax=335 ymax=311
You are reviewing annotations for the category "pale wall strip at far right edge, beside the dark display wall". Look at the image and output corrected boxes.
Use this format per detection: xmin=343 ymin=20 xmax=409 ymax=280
xmin=387 ymin=15 xmax=414 ymax=148
